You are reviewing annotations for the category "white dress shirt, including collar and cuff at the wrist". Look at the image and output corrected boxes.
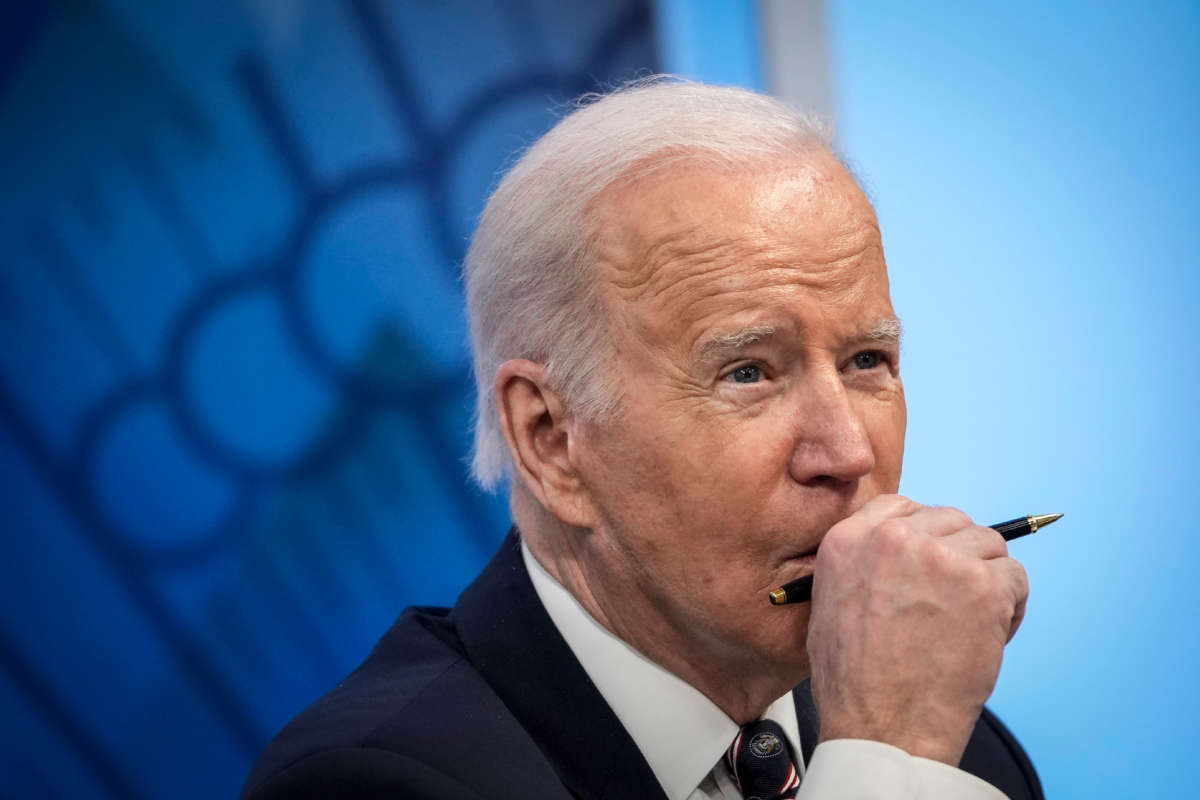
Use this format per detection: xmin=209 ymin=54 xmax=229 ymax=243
xmin=521 ymin=541 xmax=1006 ymax=800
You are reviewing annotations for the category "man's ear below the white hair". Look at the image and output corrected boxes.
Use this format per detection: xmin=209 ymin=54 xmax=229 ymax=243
xmin=493 ymin=359 xmax=593 ymax=528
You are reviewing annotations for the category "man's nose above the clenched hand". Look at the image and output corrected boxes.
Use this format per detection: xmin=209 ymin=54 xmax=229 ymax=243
xmin=790 ymin=371 xmax=875 ymax=483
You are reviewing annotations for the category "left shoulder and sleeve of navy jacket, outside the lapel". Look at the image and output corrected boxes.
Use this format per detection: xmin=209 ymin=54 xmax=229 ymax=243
xmin=242 ymin=608 xmax=563 ymax=800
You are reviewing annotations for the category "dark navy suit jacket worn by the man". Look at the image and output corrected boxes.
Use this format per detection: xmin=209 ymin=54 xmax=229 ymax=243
xmin=242 ymin=535 xmax=1043 ymax=800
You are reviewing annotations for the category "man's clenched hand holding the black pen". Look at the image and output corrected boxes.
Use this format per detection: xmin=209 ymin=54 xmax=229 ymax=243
xmin=808 ymin=494 xmax=1028 ymax=766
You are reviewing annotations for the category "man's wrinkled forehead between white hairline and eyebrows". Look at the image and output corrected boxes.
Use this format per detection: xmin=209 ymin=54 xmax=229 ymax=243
xmin=595 ymin=152 xmax=892 ymax=345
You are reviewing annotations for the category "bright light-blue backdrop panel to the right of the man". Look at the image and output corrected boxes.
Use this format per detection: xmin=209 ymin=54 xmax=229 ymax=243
xmin=830 ymin=2 xmax=1200 ymax=798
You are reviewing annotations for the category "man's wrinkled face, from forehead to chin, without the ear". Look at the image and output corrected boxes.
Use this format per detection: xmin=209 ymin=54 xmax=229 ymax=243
xmin=566 ymin=154 xmax=906 ymax=673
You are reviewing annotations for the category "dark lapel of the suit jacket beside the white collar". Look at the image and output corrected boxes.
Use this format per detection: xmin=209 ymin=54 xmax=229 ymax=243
xmin=454 ymin=529 xmax=665 ymax=800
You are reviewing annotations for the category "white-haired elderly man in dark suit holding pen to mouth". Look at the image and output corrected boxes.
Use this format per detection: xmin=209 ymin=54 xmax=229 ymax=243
xmin=247 ymin=80 xmax=1042 ymax=800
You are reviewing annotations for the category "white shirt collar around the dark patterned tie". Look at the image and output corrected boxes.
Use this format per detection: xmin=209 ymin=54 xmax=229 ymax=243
xmin=521 ymin=540 xmax=803 ymax=800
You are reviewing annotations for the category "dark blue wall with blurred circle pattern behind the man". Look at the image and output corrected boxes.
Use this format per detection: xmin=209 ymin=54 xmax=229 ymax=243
xmin=0 ymin=0 xmax=658 ymax=798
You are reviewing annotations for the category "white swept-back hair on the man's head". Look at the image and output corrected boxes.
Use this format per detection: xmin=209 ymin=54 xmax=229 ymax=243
xmin=463 ymin=76 xmax=832 ymax=488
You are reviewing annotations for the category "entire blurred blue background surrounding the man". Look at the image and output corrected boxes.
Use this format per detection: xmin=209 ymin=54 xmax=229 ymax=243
xmin=0 ymin=0 xmax=1200 ymax=798
